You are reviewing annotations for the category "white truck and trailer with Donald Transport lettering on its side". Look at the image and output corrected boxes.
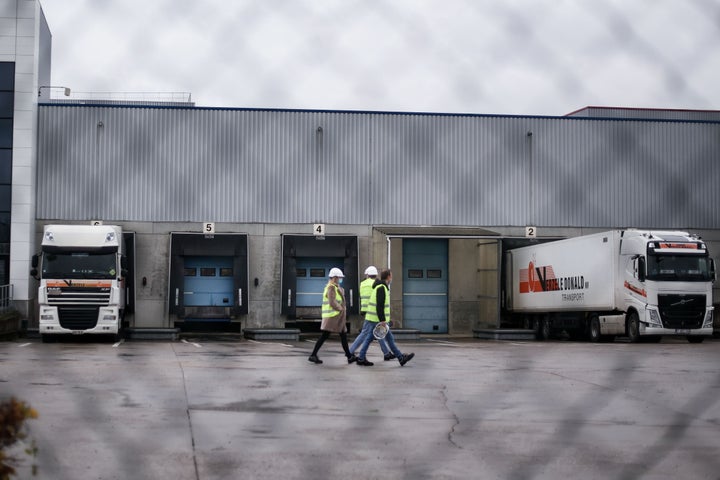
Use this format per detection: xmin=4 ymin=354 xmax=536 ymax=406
xmin=504 ymin=230 xmax=715 ymax=343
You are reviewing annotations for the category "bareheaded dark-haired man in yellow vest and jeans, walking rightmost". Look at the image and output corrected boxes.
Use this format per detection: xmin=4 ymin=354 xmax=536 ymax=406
xmin=357 ymin=269 xmax=415 ymax=367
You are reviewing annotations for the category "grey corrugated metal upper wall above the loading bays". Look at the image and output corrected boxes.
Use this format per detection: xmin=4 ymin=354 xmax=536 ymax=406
xmin=37 ymin=105 xmax=720 ymax=228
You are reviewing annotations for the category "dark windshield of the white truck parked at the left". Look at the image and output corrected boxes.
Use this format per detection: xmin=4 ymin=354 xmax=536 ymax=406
xmin=42 ymin=252 xmax=117 ymax=279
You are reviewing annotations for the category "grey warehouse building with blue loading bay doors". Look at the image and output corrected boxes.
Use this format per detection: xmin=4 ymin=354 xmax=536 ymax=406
xmin=0 ymin=1 xmax=720 ymax=333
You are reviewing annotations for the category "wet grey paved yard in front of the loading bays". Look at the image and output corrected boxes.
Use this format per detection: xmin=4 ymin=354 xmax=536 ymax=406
xmin=0 ymin=336 xmax=720 ymax=480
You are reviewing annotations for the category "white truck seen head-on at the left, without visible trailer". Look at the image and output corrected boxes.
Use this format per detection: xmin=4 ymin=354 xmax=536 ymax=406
xmin=31 ymin=225 xmax=127 ymax=342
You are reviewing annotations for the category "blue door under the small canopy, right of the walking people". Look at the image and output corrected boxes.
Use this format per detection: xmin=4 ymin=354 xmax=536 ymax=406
xmin=402 ymin=239 xmax=448 ymax=333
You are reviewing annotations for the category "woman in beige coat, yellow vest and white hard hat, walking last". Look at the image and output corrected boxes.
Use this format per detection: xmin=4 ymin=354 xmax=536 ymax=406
xmin=308 ymin=268 xmax=357 ymax=364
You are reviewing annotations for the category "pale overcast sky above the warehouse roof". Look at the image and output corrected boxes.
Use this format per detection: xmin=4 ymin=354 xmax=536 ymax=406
xmin=41 ymin=0 xmax=720 ymax=115
